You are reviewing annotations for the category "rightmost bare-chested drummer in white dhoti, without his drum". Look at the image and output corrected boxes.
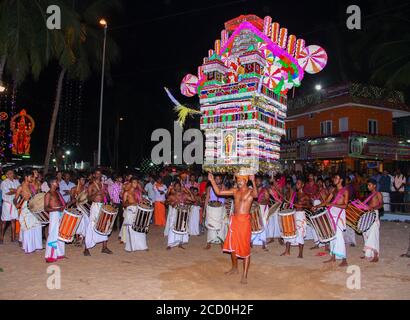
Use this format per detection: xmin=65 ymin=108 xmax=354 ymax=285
xmin=361 ymin=179 xmax=383 ymax=262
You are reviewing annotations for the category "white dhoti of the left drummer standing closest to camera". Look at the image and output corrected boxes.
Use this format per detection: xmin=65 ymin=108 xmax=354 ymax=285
xmin=45 ymin=211 xmax=65 ymax=261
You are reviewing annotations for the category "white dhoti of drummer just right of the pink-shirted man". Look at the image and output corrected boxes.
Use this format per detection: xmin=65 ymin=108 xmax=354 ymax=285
xmin=123 ymin=206 xmax=148 ymax=252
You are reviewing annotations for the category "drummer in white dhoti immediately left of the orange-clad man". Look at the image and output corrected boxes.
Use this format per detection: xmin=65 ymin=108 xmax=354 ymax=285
xmin=204 ymin=176 xmax=228 ymax=250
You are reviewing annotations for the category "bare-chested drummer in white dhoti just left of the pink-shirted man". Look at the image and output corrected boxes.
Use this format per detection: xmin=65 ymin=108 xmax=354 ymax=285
xmin=84 ymin=169 xmax=112 ymax=256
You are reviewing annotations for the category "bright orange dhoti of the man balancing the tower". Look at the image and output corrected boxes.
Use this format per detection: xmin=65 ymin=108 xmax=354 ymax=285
xmin=223 ymin=214 xmax=252 ymax=258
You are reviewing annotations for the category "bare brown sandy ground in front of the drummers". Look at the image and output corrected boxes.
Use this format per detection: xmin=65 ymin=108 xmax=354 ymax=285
xmin=0 ymin=222 xmax=410 ymax=300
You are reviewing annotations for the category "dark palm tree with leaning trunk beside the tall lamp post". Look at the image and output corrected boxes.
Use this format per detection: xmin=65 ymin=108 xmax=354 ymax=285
xmin=44 ymin=0 xmax=120 ymax=173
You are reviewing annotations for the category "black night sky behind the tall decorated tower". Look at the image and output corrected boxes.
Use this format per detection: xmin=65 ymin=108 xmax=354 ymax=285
xmin=11 ymin=0 xmax=410 ymax=167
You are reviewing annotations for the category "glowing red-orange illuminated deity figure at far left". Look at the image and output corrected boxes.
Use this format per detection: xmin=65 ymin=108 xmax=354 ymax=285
xmin=10 ymin=109 xmax=35 ymax=156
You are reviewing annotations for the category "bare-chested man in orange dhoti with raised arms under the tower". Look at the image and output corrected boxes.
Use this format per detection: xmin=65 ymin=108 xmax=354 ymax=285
xmin=208 ymin=173 xmax=258 ymax=284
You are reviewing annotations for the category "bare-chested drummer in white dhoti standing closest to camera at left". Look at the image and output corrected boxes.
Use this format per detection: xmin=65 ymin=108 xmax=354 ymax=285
xmin=44 ymin=176 xmax=66 ymax=263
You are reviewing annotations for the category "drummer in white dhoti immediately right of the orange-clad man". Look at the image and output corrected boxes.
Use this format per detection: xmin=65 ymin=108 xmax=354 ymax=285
xmin=251 ymin=177 xmax=269 ymax=251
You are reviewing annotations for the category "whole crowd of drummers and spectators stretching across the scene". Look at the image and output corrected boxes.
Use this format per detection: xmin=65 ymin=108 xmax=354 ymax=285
xmin=0 ymin=168 xmax=410 ymax=283
